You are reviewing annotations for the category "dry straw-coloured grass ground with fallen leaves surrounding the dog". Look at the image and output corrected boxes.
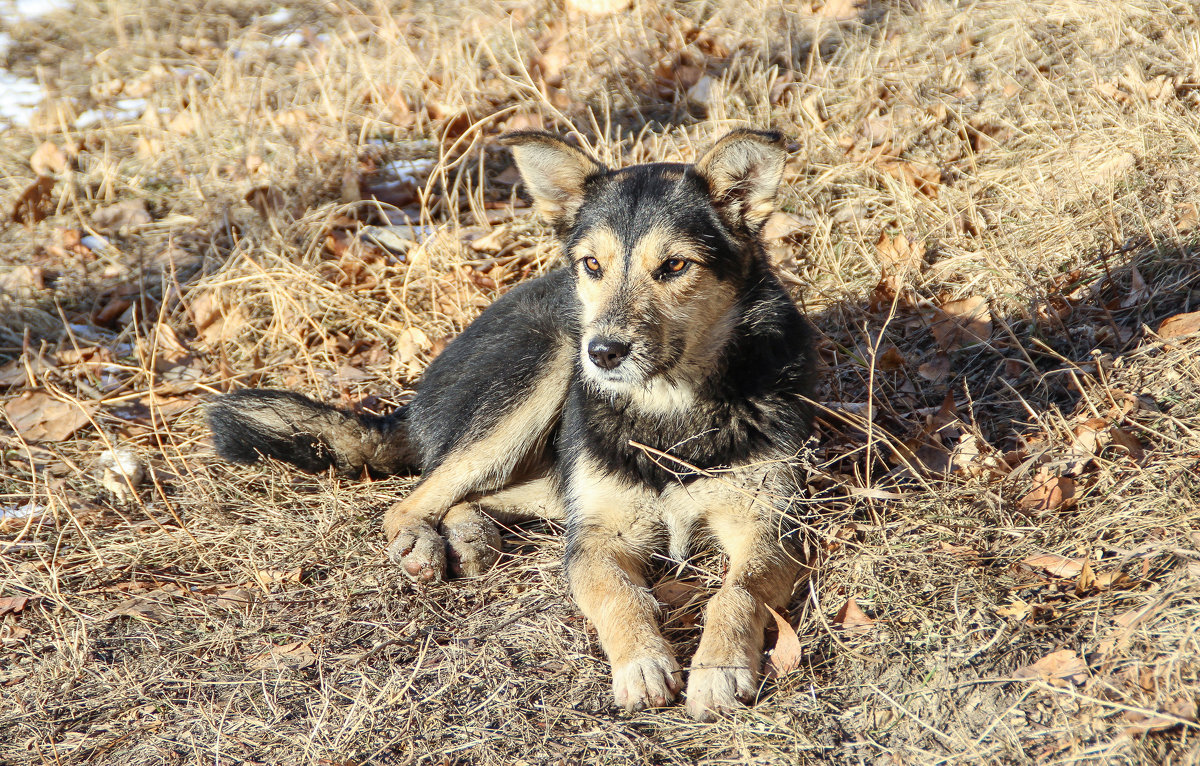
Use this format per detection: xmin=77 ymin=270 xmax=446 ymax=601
xmin=0 ymin=0 xmax=1200 ymax=766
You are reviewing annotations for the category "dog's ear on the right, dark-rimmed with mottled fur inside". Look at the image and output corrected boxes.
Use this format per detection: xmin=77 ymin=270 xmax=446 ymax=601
xmin=696 ymin=128 xmax=787 ymax=235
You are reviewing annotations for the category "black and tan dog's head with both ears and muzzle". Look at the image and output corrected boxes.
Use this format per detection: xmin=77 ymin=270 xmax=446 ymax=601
xmin=503 ymin=130 xmax=786 ymax=408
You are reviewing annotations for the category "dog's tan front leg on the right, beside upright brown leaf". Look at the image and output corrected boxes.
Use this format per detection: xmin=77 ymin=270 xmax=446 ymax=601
xmin=688 ymin=494 xmax=803 ymax=720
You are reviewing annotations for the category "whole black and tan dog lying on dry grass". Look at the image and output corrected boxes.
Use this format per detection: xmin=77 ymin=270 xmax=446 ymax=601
xmin=208 ymin=130 xmax=816 ymax=720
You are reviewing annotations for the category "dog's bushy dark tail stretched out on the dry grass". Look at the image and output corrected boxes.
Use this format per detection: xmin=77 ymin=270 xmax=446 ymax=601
xmin=206 ymin=389 xmax=419 ymax=475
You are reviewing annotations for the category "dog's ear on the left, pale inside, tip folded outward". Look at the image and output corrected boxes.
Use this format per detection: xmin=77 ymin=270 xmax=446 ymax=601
xmin=500 ymin=131 xmax=608 ymax=232
